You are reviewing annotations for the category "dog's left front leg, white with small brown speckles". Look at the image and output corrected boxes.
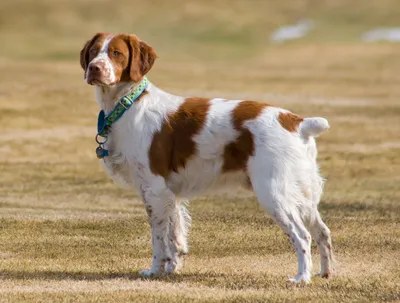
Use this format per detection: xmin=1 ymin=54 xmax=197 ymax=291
xmin=140 ymin=182 xmax=175 ymax=277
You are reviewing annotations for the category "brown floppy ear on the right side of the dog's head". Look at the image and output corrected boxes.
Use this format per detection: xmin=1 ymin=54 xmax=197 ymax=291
xmin=127 ymin=35 xmax=157 ymax=82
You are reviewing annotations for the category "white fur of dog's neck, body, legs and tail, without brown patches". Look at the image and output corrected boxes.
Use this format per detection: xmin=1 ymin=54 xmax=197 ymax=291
xmin=92 ymin=79 xmax=332 ymax=283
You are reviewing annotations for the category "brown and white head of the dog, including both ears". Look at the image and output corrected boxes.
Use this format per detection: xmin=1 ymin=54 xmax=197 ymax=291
xmin=80 ymin=33 xmax=157 ymax=86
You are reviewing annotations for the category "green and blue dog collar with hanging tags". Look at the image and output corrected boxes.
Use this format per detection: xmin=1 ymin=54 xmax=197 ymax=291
xmin=96 ymin=77 xmax=149 ymax=159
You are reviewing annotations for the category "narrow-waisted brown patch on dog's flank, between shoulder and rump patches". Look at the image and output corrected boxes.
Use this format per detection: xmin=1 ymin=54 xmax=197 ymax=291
xmin=222 ymin=101 xmax=269 ymax=172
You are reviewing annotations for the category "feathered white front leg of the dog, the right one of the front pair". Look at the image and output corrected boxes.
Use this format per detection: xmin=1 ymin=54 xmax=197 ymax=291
xmin=166 ymin=201 xmax=191 ymax=273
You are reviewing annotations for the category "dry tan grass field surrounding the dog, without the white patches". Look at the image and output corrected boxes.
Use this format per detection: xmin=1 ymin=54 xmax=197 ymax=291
xmin=0 ymin=0 xmax=400 ymax=302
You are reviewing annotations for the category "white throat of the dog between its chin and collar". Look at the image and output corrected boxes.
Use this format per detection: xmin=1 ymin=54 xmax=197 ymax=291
xmin=96 ymin=81 xmax=136 ymax=115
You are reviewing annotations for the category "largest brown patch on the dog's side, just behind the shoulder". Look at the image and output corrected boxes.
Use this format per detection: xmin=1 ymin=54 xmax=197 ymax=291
xmin=149 ymin=98 xmax=210 ymax=178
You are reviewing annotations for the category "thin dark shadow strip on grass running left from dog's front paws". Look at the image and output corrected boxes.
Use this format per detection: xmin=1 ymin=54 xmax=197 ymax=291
xmin=0 ymin=270 xmax=225 ymax=283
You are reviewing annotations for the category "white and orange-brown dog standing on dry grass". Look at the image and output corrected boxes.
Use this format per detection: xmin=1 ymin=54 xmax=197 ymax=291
xmin=80 ymin=33 xmax=333 ymax=283
